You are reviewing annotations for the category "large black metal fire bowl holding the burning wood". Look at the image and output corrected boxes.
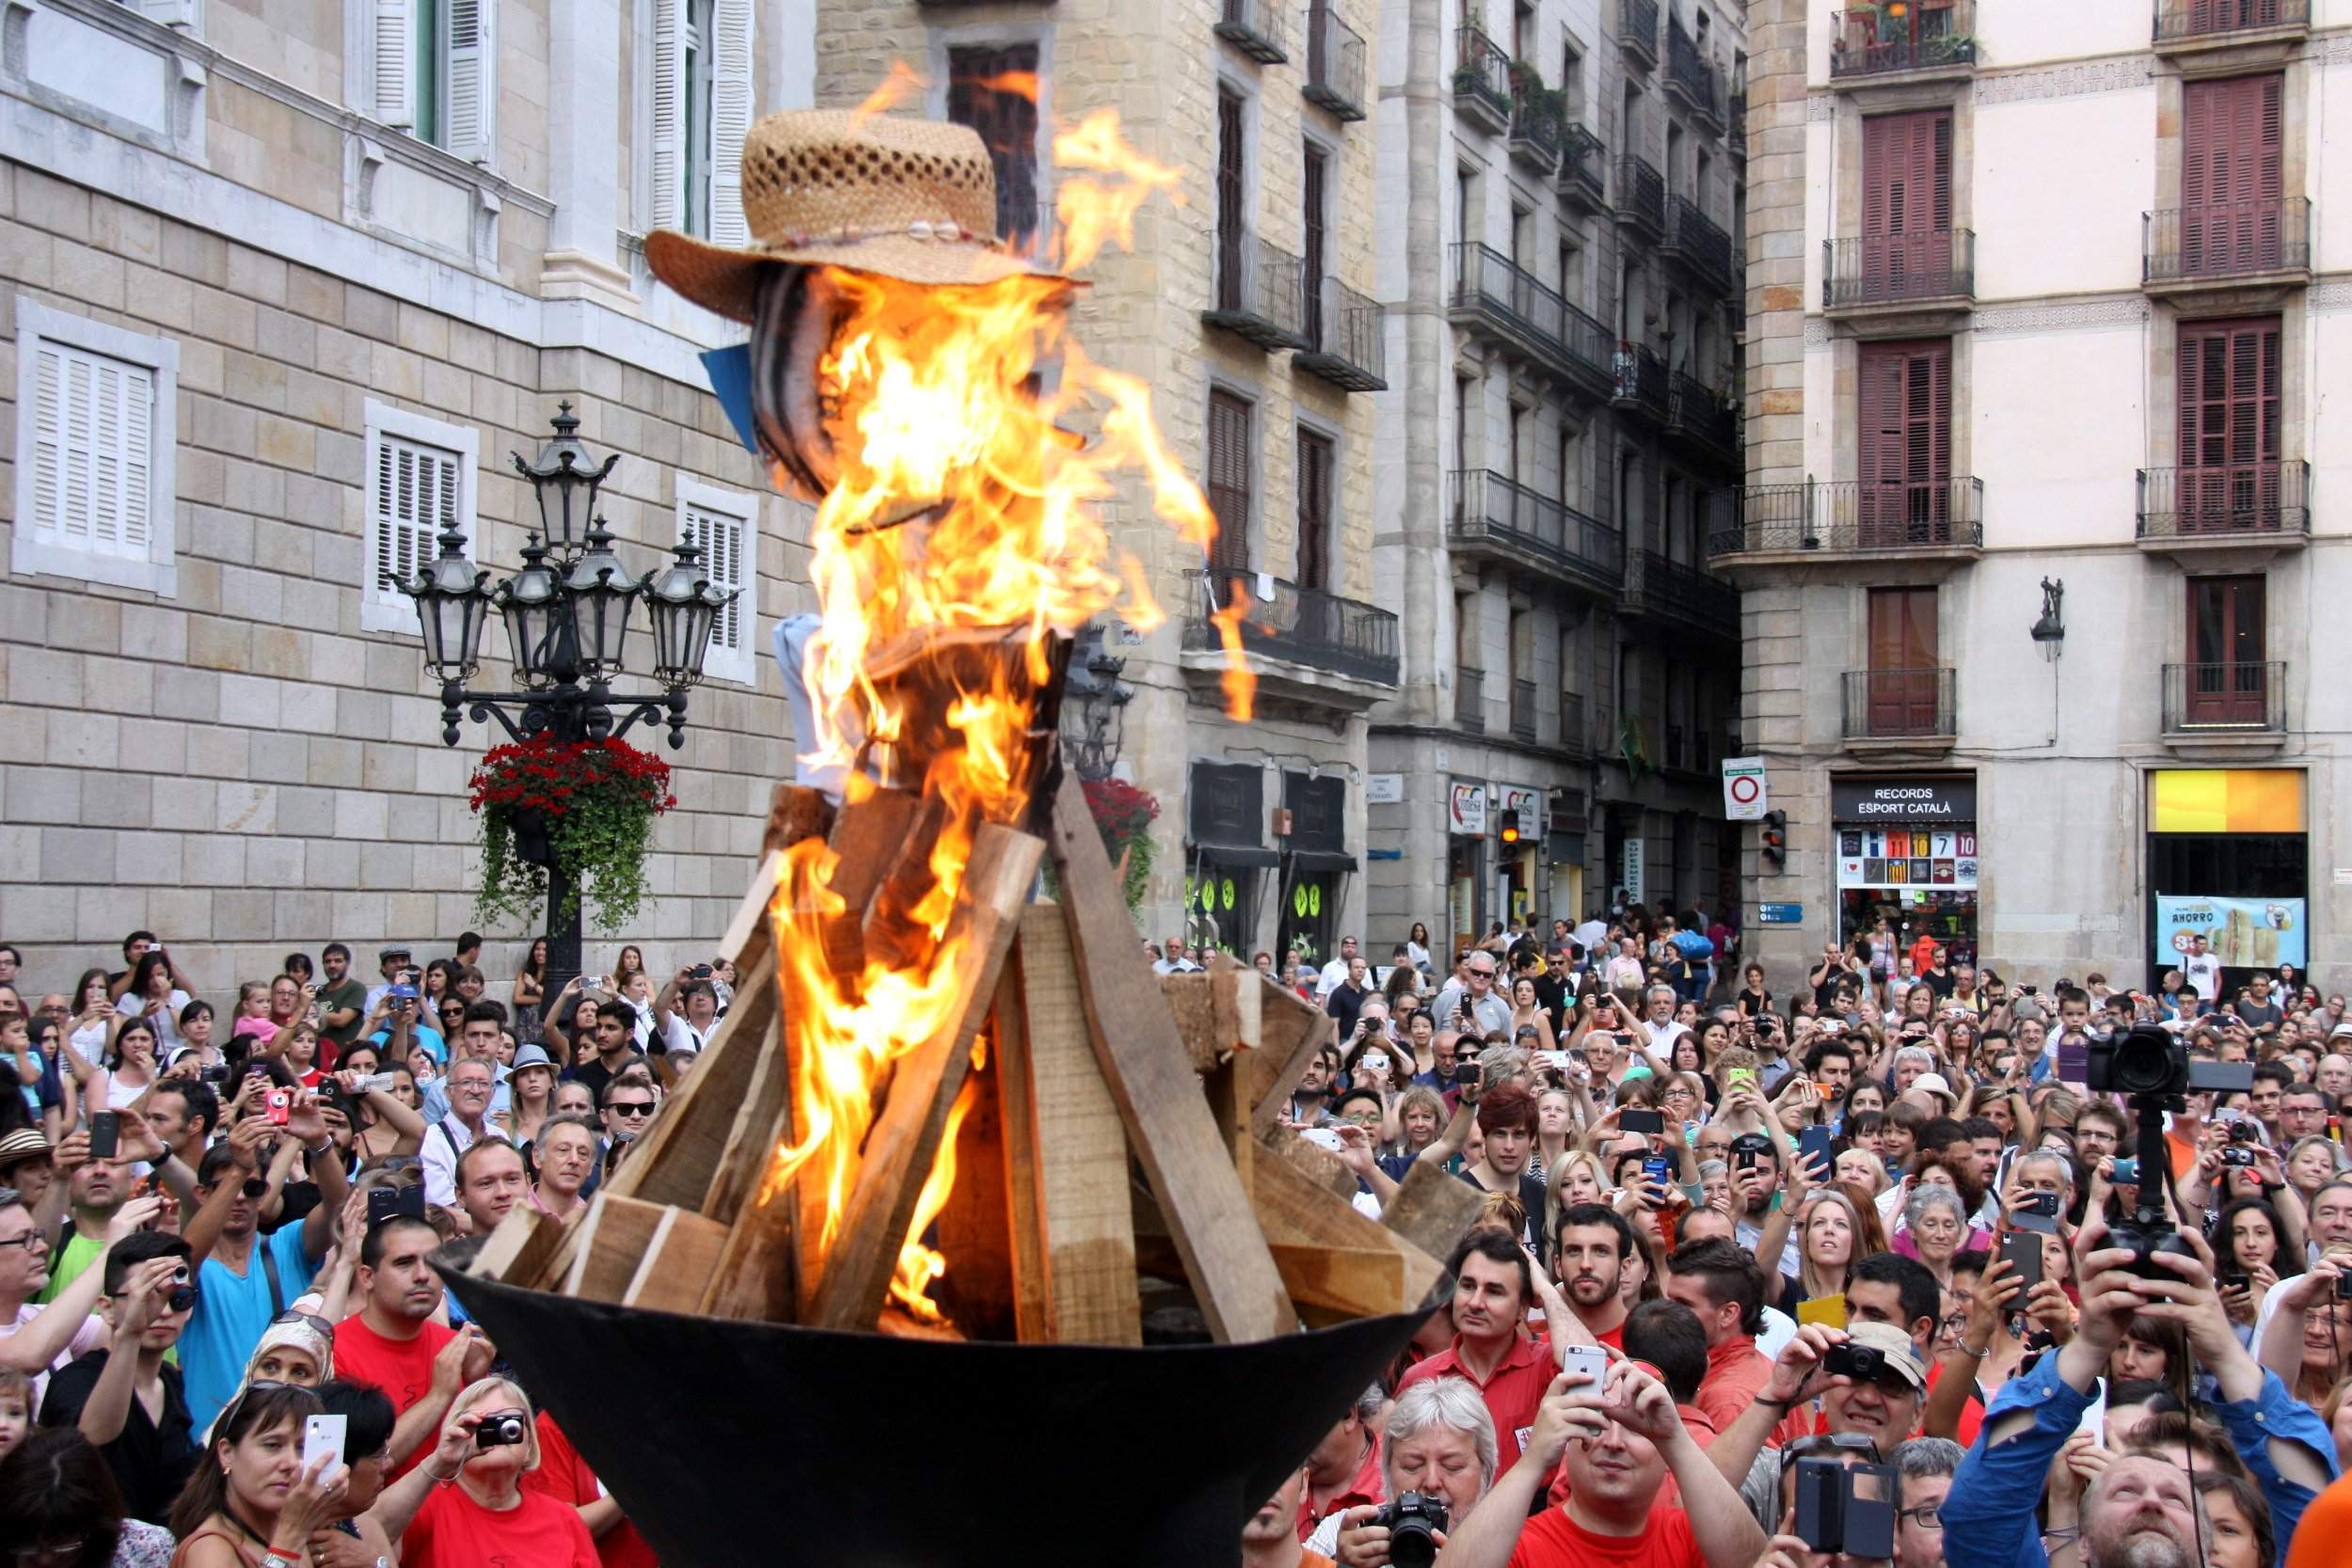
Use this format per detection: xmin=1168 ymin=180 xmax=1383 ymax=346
xmin=447 ymin=1272 xmax=1425 ymax=1568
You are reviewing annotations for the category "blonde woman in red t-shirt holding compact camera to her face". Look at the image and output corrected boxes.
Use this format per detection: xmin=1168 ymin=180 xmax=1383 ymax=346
xmin=374 ymin=1378 xmax=597 ymax=1568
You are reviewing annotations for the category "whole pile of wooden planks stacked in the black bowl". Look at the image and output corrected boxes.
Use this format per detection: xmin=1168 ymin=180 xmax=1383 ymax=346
xmin=473 ymin=778 xmax=1477 ymax=1345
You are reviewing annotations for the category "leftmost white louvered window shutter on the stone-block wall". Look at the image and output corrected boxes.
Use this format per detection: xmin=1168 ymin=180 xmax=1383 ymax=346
xmin=24 ymin=341 xmax=155 ymax=560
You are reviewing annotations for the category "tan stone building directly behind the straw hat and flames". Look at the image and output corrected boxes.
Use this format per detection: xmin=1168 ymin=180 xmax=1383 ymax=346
xmin=817 ymin=0 xmax=1402 ymax=961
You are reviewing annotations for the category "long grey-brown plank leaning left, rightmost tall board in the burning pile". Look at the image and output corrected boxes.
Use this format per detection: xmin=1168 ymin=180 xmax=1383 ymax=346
xmin=1052 ymin=773 xmax=1298 ymax=1342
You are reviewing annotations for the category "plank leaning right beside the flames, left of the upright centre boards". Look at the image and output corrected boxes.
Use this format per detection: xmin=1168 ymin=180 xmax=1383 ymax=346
xmin=807 ymin=823 xmax=1044 ymax=1328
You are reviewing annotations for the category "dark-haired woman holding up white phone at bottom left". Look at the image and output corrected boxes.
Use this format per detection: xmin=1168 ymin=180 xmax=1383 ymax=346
xmin=169 ymin=1383 xmax=343 ymax=1568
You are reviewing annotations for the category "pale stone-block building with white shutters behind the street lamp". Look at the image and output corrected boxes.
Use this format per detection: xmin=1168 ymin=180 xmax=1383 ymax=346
xmin=0 ymin=0 xmax=828 ymax=997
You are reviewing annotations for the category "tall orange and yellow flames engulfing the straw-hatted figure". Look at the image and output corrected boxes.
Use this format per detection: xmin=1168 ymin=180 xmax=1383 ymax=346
xmin=760 ymin=103 xmax=1249 ymax=1314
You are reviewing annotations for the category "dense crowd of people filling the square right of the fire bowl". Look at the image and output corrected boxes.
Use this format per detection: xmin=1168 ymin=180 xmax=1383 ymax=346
xmin=1232 ymin=905 xmax=2352 ymax=1568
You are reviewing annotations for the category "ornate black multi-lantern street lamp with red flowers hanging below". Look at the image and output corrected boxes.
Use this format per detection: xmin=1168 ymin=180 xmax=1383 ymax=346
xmin=403 ymin=402 xmax=741 ymax=990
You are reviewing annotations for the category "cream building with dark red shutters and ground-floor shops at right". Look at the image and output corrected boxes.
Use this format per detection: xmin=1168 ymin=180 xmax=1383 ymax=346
xmin=1715 ymin=0 xmax=2352 ymax=985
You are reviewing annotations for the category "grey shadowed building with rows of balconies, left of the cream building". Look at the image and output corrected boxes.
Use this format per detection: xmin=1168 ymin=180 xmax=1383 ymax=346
xmin=1372 ymin=0 xmax=1745 ymax=955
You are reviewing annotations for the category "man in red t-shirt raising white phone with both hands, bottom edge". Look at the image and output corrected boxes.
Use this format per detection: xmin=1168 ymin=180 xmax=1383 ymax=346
xmin=1447 ymin=1361 xmax=1767 ymax=1568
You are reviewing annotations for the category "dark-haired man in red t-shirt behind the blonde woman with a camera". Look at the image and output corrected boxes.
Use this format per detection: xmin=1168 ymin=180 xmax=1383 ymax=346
xmin=334 ymin=1215 xmax=497 ymax=1477
